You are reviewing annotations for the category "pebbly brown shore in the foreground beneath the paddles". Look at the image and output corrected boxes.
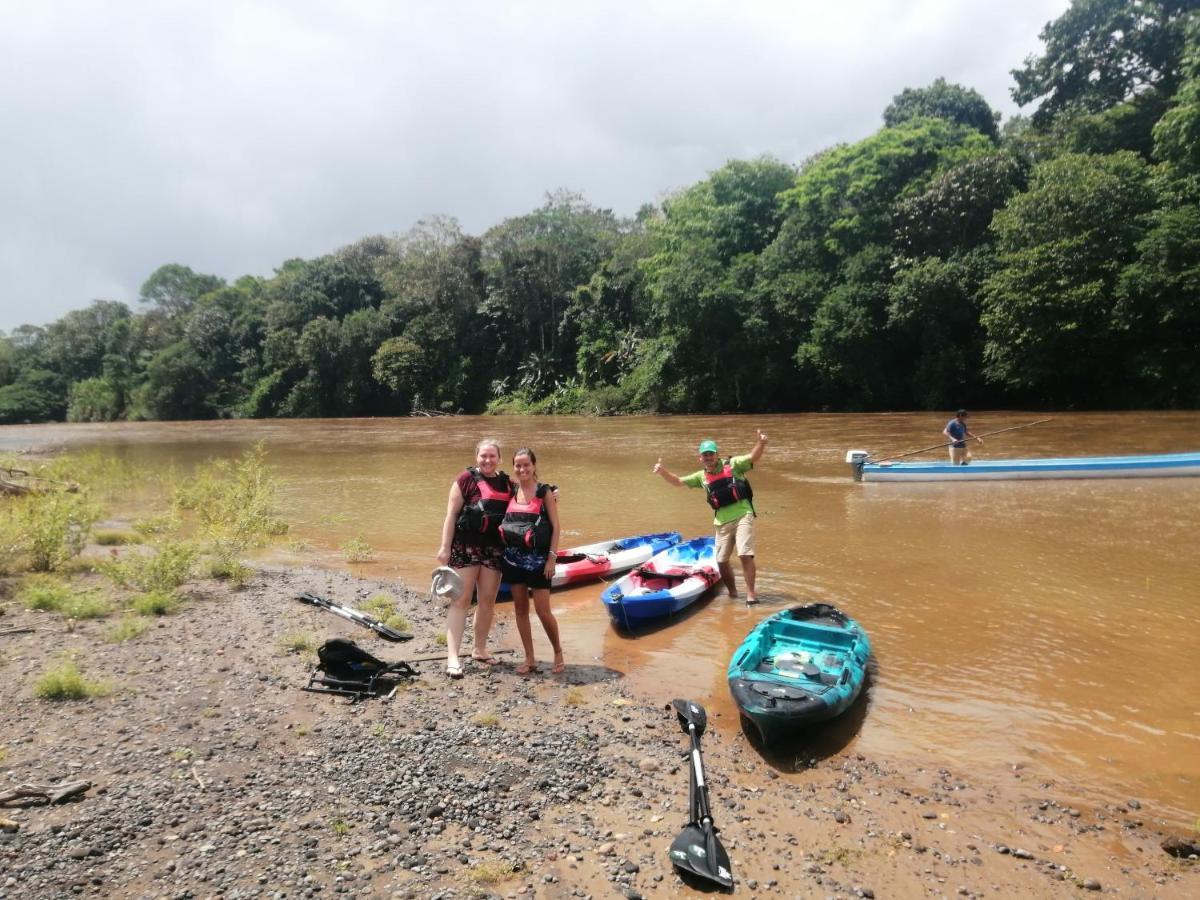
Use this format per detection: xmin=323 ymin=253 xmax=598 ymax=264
xmin=0 ymin=569 xmax=1200 ymax=900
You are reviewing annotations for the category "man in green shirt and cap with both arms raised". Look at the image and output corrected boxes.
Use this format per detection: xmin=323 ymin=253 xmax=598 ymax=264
xmin=654 ymin=431 xmax=767 ymax=604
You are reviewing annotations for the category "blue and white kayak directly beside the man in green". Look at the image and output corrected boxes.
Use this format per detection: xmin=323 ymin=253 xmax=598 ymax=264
xmin=600 ymin=538 xmax=721 ymax=629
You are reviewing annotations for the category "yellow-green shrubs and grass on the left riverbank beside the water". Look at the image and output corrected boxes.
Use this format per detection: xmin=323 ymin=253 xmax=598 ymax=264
xmin=0 ymin=445 xmax=287 ymax=657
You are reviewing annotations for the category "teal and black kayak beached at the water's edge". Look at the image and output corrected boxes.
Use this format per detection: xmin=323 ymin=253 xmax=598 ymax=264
xmin=726 ymin=604 xmax=871 ymax=744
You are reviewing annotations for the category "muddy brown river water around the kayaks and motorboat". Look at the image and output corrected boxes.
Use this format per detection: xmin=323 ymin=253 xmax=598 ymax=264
xmin=9 ymin=413 xmax=1200 ymax=822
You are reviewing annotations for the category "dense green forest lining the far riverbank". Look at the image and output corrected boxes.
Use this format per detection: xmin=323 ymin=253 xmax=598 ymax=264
xmin=0 ymin=0 xmax=1200 ymax=422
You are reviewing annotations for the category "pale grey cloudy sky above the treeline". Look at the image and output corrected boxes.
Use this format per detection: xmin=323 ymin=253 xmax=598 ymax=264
xmin=0 ymin=0 xmax=1068 ymax=330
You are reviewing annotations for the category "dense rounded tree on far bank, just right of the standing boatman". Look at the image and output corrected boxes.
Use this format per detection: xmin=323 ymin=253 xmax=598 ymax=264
xmin=982 ymin=151 xmax=1156 ymax=404
